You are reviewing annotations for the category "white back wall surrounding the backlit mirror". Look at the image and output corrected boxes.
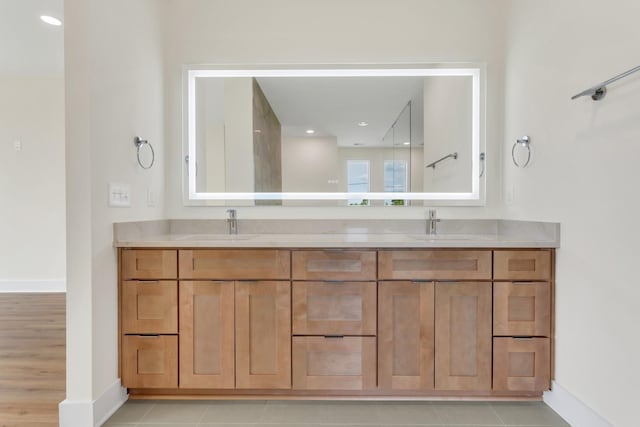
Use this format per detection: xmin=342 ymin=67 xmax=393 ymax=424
xmin=165 ymin=0 xmax=507 ymax=218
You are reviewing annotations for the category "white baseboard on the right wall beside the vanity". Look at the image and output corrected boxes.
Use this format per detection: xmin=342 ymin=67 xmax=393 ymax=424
xmin=543 ymin=381 xmax=613 ymax=427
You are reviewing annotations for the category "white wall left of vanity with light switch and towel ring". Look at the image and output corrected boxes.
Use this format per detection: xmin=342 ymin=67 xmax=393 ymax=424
xmin=61 ymin=0 xmax=165 ymax=427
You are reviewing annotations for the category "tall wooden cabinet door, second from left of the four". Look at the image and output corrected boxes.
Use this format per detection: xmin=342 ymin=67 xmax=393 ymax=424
xmin=236 ymin=281 xmax=291 ymax=389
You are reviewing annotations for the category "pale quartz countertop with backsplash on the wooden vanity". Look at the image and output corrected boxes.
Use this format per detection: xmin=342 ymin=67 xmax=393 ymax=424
xmin=114 ymin=220 xmax=560 ymax=248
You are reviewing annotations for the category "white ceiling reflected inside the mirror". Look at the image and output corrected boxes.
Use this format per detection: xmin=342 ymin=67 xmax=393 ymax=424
xmin=256 ymin=76 xmax=424 ymax=147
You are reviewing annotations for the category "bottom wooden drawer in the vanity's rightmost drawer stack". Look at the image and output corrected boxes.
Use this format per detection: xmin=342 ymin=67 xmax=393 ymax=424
xmin=493 ymin=337 xmax=551 ymax=391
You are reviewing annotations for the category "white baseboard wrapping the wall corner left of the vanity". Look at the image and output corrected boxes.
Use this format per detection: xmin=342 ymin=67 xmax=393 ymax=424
xmin=59 ymin=380 xmax=127 ymax=427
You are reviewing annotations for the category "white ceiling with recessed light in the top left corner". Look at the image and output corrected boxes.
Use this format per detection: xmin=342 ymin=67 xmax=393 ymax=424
xmin=0 ymin=0 xmax=64 ymax=76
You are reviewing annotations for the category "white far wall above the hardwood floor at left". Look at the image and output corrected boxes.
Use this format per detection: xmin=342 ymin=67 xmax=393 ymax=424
xmin=0 ymin=76 xmax=66 ymax=290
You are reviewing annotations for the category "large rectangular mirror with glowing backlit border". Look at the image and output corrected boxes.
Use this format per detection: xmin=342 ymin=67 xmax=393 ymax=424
xmin=184 ymin=65 xmax=484 ymax=206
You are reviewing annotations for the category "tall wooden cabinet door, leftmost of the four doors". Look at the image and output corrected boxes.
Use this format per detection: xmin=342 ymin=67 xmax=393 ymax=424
xmin=180 ymin=281 xmax=235 ymax=388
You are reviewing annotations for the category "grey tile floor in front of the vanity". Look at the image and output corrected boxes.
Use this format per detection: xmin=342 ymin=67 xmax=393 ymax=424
xmin=104 ymin=401 xmax=569 ymax=427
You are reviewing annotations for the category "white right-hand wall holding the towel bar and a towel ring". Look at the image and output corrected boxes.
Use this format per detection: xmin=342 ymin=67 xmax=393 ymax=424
xmin=503 ymin=0 xmax=640 ymax=427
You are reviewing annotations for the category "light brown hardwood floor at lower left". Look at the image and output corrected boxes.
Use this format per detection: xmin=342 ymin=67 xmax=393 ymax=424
xmin=0 ymin=293 xmax=66 ymax=427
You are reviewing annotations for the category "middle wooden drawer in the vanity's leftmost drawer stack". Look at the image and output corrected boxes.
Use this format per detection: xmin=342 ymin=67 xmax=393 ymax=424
xmin=122 ymin=280 xmax=178 ymax=334
